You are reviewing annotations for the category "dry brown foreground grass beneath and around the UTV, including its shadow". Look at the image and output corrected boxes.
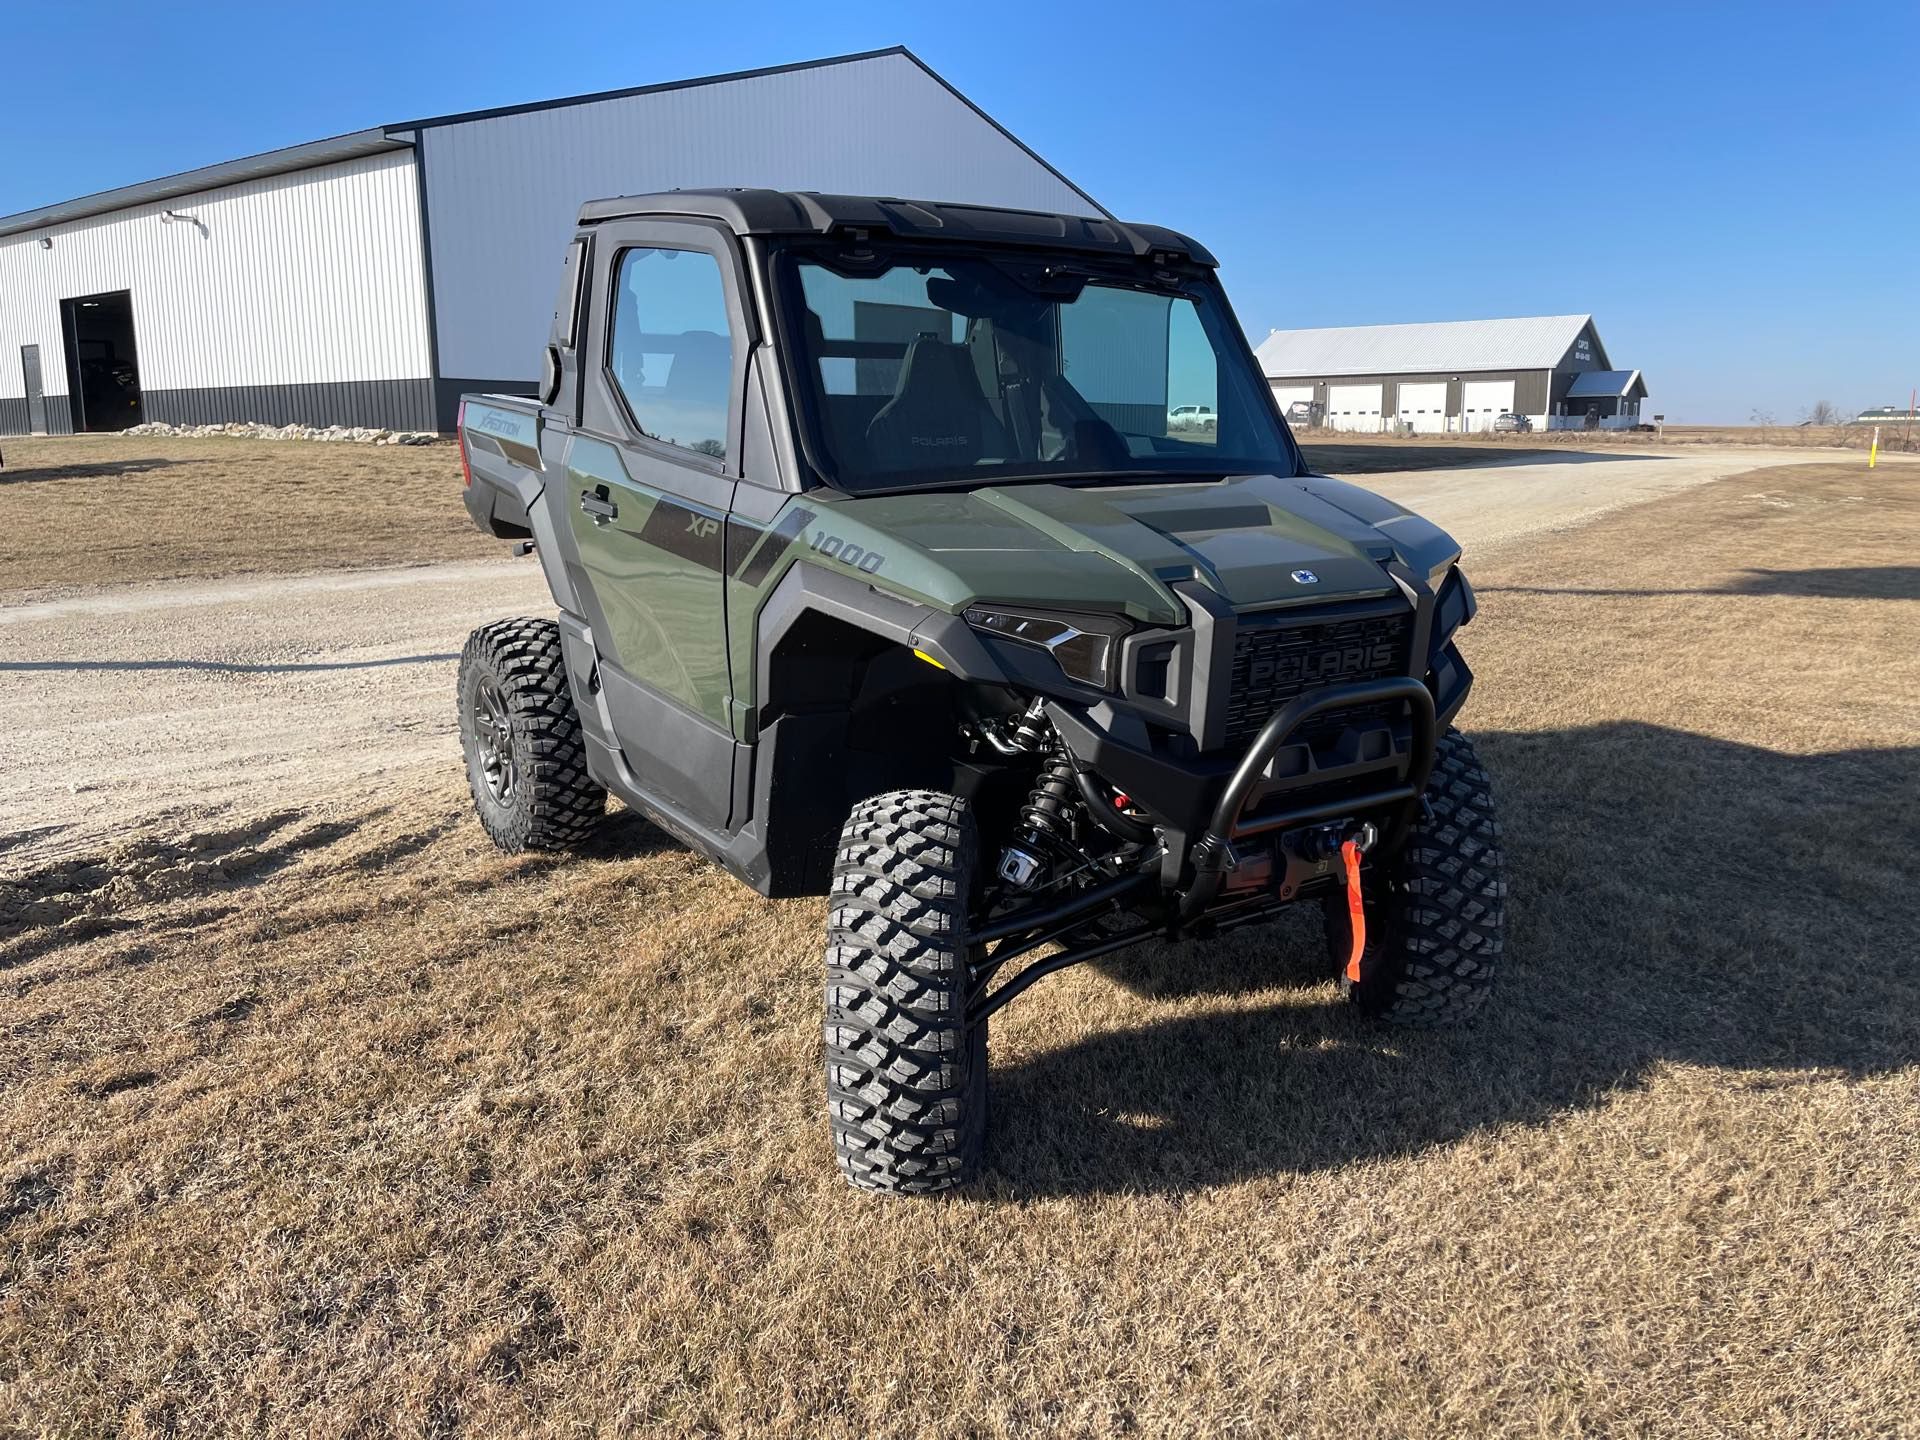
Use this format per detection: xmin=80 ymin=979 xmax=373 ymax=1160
xmin=0 ymin=467 xmax=1920 ymax=1436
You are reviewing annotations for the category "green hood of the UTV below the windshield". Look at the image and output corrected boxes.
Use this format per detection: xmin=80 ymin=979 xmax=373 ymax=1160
xmin=817 ymin=474 xmax=1457 ymax=624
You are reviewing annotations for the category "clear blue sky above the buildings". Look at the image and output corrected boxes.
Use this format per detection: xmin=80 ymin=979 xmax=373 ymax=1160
xmin=0 ymin=0 xmax=1920 ymax=422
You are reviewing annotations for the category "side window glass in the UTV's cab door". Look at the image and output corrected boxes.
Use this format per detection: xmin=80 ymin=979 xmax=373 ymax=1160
xmin=607 ymin=250 xmax=733 ymax=459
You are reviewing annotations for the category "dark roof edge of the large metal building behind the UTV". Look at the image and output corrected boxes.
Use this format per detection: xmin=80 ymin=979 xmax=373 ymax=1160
xmin=0 ymin=44 xmax=1108 ymax=236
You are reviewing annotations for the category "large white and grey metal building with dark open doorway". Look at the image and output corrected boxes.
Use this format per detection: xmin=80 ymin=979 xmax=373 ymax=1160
xmin=0 ymin=48 xmax=1104 ymax=434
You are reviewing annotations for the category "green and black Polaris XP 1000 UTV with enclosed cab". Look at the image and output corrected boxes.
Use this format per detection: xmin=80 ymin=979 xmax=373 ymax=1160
xmin=459 ymin=190 xmax=1505 ymax=1192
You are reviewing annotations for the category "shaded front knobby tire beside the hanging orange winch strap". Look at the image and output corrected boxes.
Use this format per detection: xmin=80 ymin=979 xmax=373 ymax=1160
xmin=1325 ymin=730 xmax=1507 ymax=1027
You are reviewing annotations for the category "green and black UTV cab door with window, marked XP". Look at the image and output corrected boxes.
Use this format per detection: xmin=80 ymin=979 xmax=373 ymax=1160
xmin=566 ymin=221 xmax=751 ymax=828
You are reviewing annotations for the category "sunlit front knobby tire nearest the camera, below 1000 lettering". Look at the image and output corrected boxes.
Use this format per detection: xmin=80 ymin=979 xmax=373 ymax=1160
xmin=826 ymin=789 xmax=987 ymax=1194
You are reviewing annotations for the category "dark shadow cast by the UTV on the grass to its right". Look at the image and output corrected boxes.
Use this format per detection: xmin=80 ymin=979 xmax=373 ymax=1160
xmin=989 ymin=724 xmax=1920 ymax=1194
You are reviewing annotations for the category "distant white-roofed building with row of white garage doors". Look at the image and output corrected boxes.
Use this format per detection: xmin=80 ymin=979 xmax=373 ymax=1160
xmin=1254 ymin=315 xmax=1647 ymax=434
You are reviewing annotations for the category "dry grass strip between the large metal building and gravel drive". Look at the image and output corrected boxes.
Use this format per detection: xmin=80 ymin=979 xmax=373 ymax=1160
xmin=0 ymin=436 xmax=501 ymax=599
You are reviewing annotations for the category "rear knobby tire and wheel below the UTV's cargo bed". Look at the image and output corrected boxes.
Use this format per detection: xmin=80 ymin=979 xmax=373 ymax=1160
xmin=459 ymin=618 xmax=607 ymax=854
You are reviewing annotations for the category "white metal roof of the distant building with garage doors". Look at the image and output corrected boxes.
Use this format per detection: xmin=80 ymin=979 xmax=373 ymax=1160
xmin=1254 ymin=315 xmax=1605 ymax=378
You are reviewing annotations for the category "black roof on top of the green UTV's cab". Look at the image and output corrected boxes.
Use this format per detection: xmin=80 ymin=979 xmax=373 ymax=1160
xmin=580 ymin=190 xmax=1215 ymax=265
